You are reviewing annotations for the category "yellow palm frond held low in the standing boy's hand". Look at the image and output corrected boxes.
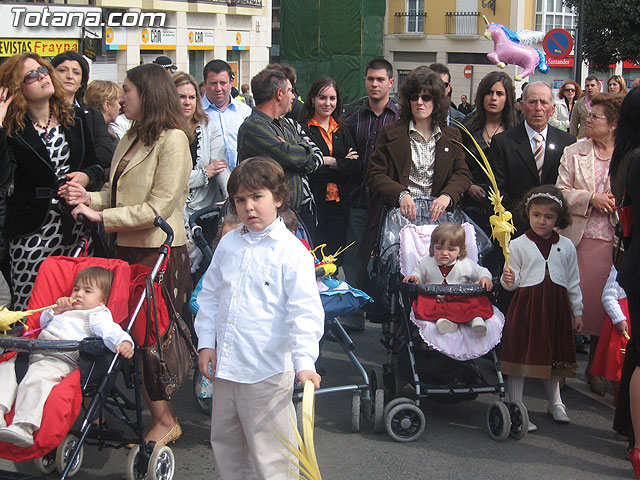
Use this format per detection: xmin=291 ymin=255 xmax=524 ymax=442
xmin=276 ymin=380 xmax=322 ymax=480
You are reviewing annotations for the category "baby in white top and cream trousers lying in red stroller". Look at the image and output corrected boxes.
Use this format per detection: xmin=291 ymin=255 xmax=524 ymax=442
xmin=0 ymin=266 xmax=133 ymax=448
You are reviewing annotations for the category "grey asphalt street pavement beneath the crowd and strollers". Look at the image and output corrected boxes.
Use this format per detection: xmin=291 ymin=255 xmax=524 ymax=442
xmin=0 ymin=324 xmax=633 ymax=480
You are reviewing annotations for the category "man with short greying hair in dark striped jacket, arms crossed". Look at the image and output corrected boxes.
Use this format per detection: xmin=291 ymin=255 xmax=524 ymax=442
xmin=238 ymin=68 xmax=324 ymax=235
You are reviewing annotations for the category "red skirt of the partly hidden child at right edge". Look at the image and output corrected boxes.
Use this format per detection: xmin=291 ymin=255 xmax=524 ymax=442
xmin=591 ymin=298 xmax=629 ymax=382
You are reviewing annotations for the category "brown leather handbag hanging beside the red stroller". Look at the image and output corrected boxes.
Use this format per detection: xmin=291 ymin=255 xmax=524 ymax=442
xmin=141 ymin=278 xmax=198 ymax=401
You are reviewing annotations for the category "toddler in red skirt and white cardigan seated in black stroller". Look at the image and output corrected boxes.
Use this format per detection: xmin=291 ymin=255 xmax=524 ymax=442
xmin=403 ymin=223 xmax=493 ymax=337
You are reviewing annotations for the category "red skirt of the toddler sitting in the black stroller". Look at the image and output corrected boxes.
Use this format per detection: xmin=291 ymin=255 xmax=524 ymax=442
xmin=413 ymin=294 xmax=493 ymax=323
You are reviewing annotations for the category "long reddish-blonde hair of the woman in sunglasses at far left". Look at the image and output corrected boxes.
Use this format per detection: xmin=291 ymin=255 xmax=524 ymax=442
xmin=0 ymin=52 xmax=74 ymax=137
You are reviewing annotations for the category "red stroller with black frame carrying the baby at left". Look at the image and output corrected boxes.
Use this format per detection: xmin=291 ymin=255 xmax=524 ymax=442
xmin=0 ymin=217 xmax=175 ymax=480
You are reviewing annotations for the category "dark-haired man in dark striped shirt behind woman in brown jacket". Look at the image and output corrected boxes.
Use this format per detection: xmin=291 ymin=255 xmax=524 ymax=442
xmin=342 ymin=58 xmax=400 ymax=331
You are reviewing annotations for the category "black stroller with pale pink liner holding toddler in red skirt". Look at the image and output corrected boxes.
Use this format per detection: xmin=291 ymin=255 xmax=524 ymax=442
xmin=364 ymin=198 xmax=529 ymax=442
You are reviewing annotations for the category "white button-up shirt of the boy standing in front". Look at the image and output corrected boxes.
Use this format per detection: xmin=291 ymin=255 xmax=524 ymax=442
xmin=194 ymin=218 xmax=324 ymax=383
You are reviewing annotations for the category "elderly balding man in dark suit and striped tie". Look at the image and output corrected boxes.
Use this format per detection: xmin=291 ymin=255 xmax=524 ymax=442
xmin=489 ymin=82 xmax=576 ymax=236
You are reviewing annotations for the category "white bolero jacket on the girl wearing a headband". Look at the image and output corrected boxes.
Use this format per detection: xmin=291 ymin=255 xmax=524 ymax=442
xmin=500 ymin=235 xmax=582 ymax=317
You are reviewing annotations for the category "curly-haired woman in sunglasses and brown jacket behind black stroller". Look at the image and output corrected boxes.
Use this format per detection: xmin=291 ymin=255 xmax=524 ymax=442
xmin=361 ymin=67 xmax=471 ymax=265
